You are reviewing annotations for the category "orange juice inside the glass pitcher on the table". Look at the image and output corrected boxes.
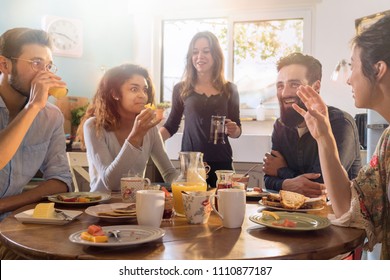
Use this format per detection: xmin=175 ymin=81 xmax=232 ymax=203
xmin=171 ymin=182 xmax=207 ymax=217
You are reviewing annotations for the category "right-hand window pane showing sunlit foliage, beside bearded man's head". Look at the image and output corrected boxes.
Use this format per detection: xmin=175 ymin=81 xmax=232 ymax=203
xmin=233 ymin=19 xmax=303 ymax=109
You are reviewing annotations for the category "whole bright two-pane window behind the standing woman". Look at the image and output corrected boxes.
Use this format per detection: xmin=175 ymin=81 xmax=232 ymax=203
xmin=161 ymin=14 xmax=304 ymax=115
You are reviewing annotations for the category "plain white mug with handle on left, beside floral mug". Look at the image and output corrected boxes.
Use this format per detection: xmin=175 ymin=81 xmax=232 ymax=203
xmin=210 ymin=189 xmax=246 ymax=228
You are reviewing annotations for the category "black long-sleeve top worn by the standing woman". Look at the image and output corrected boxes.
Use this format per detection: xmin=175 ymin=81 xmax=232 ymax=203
xmin=164 ymin=83 xmax=241 ymax=162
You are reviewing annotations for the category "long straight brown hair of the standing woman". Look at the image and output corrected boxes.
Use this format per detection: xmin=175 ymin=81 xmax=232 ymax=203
xmin=181 ymin=31 xmax=230 ymax=97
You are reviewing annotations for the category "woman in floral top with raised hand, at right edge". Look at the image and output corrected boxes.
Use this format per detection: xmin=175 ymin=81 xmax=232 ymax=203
xmin=293 ymin=16 xmax=390 ymax=259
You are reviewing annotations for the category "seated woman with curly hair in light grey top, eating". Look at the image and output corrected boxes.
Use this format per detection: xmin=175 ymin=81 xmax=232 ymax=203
xmin=78 ymin=64 xmax=178 ymax=192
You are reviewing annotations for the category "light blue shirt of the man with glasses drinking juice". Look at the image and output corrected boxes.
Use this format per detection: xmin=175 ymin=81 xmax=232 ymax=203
xmin=0 ymin=97 xmax=72 ymax=221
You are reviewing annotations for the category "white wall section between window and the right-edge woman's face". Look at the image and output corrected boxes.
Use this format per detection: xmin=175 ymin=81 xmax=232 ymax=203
xmin=313 ymin=0 xmax=390 ymax=116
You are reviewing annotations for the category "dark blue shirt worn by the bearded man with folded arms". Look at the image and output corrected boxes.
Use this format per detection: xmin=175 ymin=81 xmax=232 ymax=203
xmin=264 ymin=106 xmax=361 ymax=192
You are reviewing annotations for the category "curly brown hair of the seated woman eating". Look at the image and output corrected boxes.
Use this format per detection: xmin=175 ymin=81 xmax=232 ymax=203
xmin=77 ymin=64 xmax=155 ymax=145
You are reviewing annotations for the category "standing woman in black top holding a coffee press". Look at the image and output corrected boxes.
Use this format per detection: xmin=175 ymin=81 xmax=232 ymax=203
xmin=160 ymin=31 xmax=241 ymax=187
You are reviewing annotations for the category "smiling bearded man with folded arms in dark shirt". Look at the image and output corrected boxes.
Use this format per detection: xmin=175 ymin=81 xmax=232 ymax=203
xmin=263 ymin=53 xmax=361 ymax=197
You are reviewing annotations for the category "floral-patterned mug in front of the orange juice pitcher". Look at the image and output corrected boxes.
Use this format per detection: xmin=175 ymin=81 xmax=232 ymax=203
xmin=182 ymin=192 xmax=212 ymax=224
